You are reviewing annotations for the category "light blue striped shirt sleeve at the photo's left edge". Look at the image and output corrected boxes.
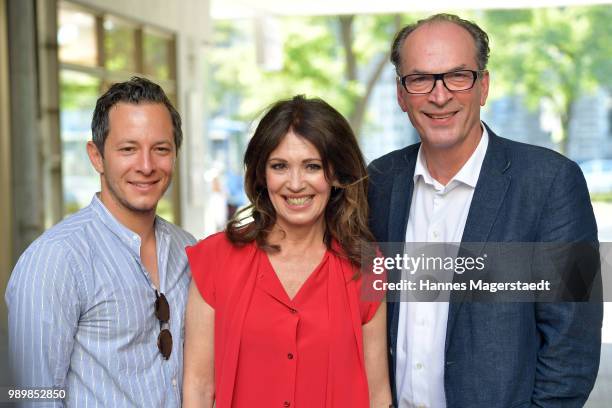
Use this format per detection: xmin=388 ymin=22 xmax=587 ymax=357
xmin=5 ymin=242 xmax=80 ymax=398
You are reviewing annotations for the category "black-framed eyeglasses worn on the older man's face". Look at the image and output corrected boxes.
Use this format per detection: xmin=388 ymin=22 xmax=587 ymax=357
xmin=400 ymin=69 xmax=486 ymax=95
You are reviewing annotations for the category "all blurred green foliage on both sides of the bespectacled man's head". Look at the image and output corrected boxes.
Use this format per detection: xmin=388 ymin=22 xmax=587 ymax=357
xmin=210 ymin=5 xmax=612 ymax=151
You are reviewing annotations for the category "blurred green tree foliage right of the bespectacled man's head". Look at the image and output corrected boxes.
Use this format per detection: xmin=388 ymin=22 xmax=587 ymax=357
xmin=484 ymin=6 xmax=612 ymax=153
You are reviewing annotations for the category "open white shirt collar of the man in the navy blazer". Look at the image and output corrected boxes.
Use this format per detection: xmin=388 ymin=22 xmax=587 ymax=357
xmin=414 ymin=122 xmax=489 ymax=188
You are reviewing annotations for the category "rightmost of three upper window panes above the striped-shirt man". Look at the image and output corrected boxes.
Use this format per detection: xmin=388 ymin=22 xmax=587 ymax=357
xmin=143 ymin=31 xmax=174 ymax=79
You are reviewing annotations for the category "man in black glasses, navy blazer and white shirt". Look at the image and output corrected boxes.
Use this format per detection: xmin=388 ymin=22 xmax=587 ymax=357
xmin=369 ymin=14 xmax=602 ymax=408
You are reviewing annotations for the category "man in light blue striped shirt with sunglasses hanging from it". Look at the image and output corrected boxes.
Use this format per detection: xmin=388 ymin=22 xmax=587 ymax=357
xmin=6 ymin=77 xmax=195 ymax=407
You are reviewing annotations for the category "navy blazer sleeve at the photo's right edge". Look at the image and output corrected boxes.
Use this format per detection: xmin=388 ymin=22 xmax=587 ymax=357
xmin=531 ymin=160 xmax=603 ymax=407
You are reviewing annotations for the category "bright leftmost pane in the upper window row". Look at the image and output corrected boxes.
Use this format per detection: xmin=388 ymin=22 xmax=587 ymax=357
xmin=57 ymin=2 xmax=98 ymax=66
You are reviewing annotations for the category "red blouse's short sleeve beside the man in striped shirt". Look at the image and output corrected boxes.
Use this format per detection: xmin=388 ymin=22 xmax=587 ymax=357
xmin=185 ymin=236 xmax=218 ymax=308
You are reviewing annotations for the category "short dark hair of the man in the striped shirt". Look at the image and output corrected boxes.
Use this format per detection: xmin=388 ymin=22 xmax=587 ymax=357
xmin=91 ymin=76 xmax=183 ymax=156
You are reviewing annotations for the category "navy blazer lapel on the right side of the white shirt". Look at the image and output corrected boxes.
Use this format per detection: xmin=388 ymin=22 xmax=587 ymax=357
xmin=446 ymin=128 xmax=511 ymax=349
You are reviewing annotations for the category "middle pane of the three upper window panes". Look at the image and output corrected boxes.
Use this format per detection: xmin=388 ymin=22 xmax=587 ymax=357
xmin=104 ymin=18 xmax=137 ymax=72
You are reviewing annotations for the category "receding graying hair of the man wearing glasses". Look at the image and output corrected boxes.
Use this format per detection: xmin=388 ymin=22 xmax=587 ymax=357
xmin=391 ymin=13 xmax=489 ymax=76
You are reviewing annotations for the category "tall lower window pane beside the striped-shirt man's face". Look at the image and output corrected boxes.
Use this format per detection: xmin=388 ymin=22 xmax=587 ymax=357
xmin=60 ymin=70 xmax=100 ymax=214
